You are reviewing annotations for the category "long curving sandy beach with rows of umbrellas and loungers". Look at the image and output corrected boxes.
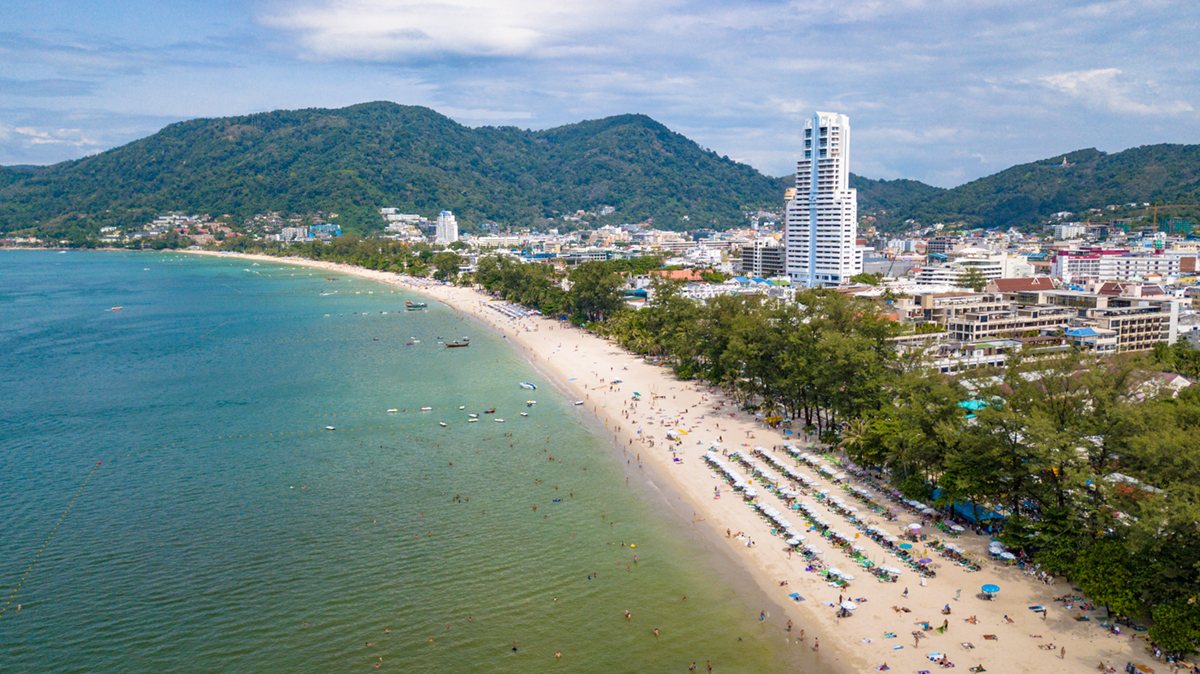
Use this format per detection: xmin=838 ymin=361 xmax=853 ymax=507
xmin=189 ymin=252 xmax=1168 ymax=673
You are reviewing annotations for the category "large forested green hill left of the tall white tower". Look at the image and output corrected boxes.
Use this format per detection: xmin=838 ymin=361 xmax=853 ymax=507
xmin=0 ymin=102 xmax=782 ymax=235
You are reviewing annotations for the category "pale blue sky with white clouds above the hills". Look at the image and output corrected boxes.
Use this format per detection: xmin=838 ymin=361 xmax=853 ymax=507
xmin=0 ymin=0 xmax=1200 ymax=187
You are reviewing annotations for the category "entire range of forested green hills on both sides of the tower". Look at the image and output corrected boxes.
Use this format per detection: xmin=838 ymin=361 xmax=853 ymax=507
xmin=0 ymin=102 xmax=1200 ymax=239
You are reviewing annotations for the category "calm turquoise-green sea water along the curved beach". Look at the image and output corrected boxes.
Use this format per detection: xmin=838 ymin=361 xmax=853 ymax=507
xmin=0 ymin=252 xmax=790 ymax=673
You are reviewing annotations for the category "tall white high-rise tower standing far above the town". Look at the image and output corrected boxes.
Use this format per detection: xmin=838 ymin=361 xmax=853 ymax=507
xmin=786 ymin=113 xmax=863 ymax=287
